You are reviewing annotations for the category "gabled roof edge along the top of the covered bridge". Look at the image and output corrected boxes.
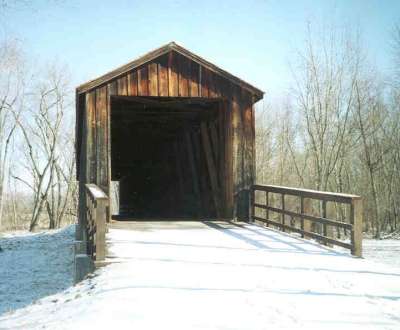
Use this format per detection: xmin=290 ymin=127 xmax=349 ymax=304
xmin=76 ymin=42 xmax=264 ymax=100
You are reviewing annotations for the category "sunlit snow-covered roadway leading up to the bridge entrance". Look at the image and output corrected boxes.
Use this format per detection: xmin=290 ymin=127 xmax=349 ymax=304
xmin=0 ymin=222 xmax=400 ymax=330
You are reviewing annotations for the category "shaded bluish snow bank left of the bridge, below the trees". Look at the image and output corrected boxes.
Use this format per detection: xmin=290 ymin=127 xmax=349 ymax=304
xmin=0 ymin=226 xmax=75 ymax=314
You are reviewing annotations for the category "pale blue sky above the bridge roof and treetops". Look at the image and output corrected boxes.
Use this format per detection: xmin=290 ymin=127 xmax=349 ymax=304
xmin=0 ymin=0 xmax=400 ymax=99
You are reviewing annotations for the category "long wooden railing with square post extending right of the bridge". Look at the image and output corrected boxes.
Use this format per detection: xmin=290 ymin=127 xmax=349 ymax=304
xmin=251 ymin=185 xmax=362 ymax=257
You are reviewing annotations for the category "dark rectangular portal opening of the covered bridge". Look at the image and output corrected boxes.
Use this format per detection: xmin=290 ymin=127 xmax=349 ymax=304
xmin=110 ymin=96 xmax=226 ymax=219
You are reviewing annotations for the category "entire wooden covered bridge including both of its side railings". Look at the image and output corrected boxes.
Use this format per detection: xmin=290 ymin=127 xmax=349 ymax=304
xmin=76 ymin=42 xmax=362 ymax=270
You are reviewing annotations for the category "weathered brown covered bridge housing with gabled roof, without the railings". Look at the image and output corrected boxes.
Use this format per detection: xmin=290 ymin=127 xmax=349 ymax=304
xmin=76 ymin=42 xmax=263 ymax=219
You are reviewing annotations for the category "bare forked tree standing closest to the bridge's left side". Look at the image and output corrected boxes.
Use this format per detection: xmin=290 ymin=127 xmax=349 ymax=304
xmin=16 ymin=63 xmax=74 ymax=230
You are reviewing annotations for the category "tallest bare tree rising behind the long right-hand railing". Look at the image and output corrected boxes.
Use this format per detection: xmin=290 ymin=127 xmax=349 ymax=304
xmin=294 ymin=26 xmax=362 ymax=190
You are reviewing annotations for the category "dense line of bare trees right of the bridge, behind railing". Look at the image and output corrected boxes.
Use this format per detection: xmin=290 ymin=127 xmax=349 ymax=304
xmin=256 ymin=26 xmax=400 ymax=238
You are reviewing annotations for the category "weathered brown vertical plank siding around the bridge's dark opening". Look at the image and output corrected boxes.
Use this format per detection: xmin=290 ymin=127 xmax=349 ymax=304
xmin=77 ymin=51 xmax=255 ymax=217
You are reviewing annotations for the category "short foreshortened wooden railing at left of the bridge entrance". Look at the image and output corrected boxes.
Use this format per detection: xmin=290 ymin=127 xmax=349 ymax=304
xmin=86 ymin=184 xmax=108 ymax=261
